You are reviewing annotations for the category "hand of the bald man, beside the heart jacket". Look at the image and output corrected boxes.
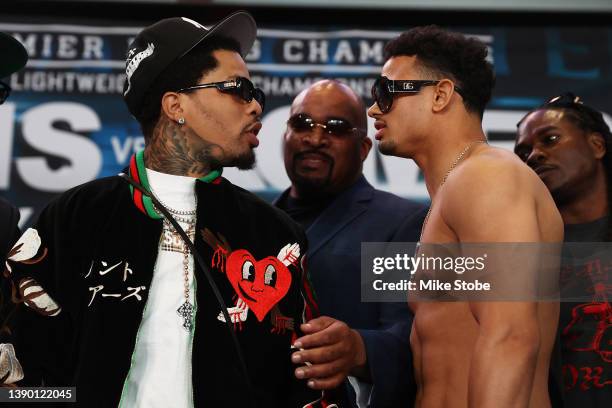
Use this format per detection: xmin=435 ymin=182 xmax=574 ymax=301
xmin=291 ymin=316 xmax=367 ymax=390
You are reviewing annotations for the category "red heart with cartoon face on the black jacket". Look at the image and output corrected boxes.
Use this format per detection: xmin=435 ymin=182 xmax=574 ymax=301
xmin=226 ymin=249 xmax=291 ymax=322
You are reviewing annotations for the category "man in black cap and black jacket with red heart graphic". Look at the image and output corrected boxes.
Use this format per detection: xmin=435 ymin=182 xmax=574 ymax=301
xmin=2 ymin=12 xmax=338 ymax=407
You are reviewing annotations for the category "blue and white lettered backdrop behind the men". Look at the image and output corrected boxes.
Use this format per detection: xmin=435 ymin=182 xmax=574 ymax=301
xmin=0 ymin=18 xmax=612 ymax=226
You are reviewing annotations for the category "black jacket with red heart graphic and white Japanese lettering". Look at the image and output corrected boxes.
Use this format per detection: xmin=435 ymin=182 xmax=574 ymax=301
xmin=3 ymin=164 xmax=334 ymax=408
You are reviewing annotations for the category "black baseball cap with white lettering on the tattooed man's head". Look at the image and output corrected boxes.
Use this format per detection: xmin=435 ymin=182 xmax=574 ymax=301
xmin=123 ymin=11 xmax=257 ymax=116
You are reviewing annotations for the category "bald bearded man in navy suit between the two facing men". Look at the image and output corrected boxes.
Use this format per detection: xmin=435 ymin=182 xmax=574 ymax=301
xmin=276 ymin=80 xmax=425 ymax=407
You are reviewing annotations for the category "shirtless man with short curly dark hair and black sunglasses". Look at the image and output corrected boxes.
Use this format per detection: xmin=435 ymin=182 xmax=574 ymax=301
xmin=368 ymin=26 xmax=563 ymax=408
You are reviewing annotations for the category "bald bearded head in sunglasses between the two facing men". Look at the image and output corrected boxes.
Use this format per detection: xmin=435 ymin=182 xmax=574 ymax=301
xmin=283 ymin=79 xmax=372 ymax=198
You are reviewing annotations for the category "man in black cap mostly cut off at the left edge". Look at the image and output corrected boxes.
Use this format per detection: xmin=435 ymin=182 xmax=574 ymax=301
xmin=0 ymin=33 xmax=28 ymax=384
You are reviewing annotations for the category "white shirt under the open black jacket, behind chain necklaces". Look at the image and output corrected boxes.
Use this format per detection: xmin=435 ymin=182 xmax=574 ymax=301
xmin=120 ymin=169 xmax=196 ymax=408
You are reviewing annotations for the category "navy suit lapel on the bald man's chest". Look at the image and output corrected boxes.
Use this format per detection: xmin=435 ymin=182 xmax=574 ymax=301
xmin=306 ymin=176 xmax=374 ymax=257
